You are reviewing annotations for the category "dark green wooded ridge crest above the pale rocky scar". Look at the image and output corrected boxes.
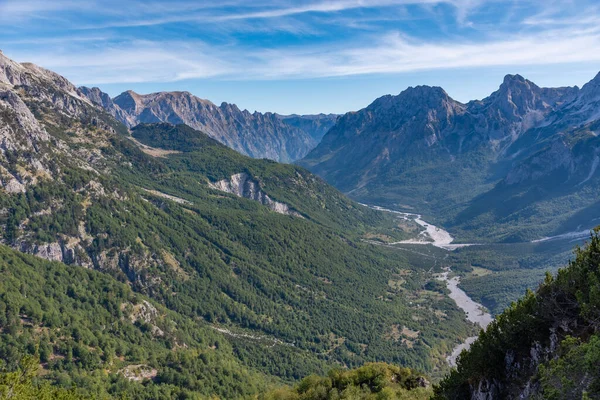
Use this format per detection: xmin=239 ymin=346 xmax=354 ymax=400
xmin=130 ymin=124 xmax=385 ymax=231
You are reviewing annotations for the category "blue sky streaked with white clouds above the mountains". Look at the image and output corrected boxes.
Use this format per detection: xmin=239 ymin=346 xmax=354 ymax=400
xmin=0 ymin=0 xmax=600 ymax=113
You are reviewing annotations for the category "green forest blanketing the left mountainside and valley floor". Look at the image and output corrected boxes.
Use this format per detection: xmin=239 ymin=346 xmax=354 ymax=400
xmin=0 ymin=70 xmax=600 ymax=400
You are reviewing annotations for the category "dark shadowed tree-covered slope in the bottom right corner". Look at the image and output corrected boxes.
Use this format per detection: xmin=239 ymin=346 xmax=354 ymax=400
xmin=434 ymin=228 xmax=600 ymax=399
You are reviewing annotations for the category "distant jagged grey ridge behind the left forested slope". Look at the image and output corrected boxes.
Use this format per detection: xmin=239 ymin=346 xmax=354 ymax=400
xmin=80 ymin=87 xmax=334 ymax=162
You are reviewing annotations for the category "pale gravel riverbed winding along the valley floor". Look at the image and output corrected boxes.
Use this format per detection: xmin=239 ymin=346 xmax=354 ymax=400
xmin=368 ymin=206 xmax=493 ymax=367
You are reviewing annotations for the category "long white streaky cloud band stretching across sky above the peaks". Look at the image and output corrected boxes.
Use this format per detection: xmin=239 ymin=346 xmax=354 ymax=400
xmin=8 ymin=22 xmax=600 ymax=84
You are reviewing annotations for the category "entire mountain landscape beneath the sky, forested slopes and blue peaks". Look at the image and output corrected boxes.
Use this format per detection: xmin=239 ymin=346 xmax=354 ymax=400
xmin=0 ymin=49 xmax=600 ymax=400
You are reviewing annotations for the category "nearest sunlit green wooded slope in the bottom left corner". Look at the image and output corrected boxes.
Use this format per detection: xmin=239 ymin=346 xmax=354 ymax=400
xmin=0 ymin=246 xmax=268 ymax=399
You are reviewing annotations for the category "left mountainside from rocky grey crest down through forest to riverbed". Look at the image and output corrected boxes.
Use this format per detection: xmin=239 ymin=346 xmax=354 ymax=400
xmin=0 ymin=50 xmax=473 ymax=398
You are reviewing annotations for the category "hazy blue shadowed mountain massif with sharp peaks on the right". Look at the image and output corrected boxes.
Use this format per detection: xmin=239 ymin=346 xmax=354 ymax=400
xmin=298 ymin=75 xmax=600 ymax=241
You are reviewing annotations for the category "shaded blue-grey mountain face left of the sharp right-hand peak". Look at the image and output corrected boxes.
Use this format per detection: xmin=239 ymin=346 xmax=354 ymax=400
xmin=298 ymin=86 xmax=485 ymax=192
